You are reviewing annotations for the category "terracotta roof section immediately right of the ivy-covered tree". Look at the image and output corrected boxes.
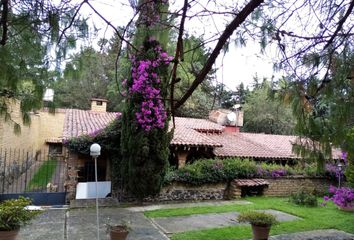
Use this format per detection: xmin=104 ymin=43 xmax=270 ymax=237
xmin=170 ymin=126 xmax=221 ymax=147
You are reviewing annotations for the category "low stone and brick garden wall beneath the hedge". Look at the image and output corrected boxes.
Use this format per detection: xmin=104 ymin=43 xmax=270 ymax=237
xmin=154 ymin=176 xmax=335 ymax=201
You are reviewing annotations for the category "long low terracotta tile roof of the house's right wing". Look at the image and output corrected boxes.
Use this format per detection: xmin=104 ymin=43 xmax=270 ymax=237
xmin=208 ymin=132 xmax=298 ymax=159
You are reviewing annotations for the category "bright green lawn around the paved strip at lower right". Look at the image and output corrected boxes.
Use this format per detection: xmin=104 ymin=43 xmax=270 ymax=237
xmin=144 ymin=197 xmax=354 ymax=240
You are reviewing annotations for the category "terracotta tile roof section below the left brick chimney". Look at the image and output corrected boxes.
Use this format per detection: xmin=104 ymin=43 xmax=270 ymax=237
xmin=63 ymin=109 xmax=121 ymax=139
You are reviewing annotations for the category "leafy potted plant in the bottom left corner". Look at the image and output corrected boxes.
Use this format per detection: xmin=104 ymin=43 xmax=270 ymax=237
xmin=0 ymin=197 xmax=40 ymax=240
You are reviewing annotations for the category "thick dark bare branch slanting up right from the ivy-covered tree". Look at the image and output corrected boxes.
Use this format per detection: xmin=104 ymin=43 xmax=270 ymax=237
xmin=174 ymin=0 xmax=264 ymax=109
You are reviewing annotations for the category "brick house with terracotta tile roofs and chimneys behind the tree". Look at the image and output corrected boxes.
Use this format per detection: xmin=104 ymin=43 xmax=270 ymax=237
xmin=0 ymin=98 xmax=340 ymax=199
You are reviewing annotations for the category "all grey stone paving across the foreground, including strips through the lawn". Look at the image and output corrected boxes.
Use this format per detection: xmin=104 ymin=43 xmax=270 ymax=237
xmin=18 ymin=203 xmax=354 ymax=240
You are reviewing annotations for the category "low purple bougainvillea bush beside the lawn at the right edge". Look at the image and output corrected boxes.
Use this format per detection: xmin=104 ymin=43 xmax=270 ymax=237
xmin=322 ymin=186 xmax=354 ymax=208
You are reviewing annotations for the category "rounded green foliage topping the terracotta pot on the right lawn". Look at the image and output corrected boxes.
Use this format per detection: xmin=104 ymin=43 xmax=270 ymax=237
xmin=237 ymin=211 xmax=278 ymax=227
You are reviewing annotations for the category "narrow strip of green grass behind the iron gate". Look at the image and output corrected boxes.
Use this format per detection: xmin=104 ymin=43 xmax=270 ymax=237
xmin=26 ymin=159 xmax=57 ymax=191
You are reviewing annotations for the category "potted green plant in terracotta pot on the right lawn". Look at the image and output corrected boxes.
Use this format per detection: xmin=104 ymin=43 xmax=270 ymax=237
xmin=237 ymin=211 xmax=278 ymax=240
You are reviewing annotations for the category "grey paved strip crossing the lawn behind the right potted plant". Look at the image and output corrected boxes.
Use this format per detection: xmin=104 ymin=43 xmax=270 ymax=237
xmin=152 ymin=210 xmax=300 ymax=235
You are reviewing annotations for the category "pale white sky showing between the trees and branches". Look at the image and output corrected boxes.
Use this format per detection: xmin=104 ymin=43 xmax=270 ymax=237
xmin=77 ymin=0 xmax=280 ymax=90
